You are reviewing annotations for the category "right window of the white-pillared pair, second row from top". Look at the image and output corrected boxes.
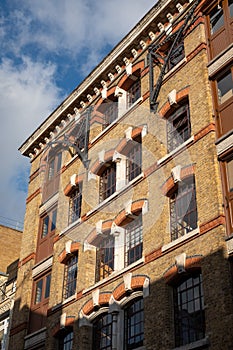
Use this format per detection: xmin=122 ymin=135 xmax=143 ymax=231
xmin=126 ymin=135 xmax=142 ymax=181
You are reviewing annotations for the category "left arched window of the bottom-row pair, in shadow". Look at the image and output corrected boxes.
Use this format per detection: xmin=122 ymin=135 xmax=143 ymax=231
xmin=92 ymin=314 xmax=112 ymax=350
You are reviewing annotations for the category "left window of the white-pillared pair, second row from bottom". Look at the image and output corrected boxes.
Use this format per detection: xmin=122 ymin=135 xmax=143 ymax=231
xmin=96 ymin=234 xmax=114 ymax=281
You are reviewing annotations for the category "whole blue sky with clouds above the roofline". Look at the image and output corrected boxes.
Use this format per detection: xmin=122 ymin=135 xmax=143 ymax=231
xmin=0 ymin=0 xmax=156 ymax=228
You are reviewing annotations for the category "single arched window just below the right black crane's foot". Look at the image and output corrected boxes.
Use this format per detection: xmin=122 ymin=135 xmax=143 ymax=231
xmin=167 ymin=101 xmax=191 ymax=152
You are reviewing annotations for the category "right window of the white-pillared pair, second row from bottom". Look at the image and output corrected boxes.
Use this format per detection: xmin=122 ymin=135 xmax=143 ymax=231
xmin=125 ymin=214 xmax=143 ymax=266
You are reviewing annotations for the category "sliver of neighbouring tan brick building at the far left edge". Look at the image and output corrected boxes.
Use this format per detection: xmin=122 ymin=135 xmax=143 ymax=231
xmin=0 ymin=225 xmax=22 ymax=350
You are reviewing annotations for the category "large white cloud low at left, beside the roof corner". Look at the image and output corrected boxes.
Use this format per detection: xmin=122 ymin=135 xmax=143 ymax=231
xmin=0 ymin=57 xmax=61 ymax=221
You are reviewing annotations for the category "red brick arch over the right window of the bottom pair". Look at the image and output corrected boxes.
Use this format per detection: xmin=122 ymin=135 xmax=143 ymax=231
xmin=112 ymin=275 xmax=149 ymax=301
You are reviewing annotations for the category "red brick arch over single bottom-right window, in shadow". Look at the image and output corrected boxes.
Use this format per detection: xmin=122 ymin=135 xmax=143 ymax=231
xmin=163 ymin=255 xmax=203 ymax=284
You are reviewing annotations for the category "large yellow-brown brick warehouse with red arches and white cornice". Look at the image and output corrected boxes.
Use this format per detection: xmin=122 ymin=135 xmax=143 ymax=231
xmin=10 ymin=0 xmax=233 ymax=350
